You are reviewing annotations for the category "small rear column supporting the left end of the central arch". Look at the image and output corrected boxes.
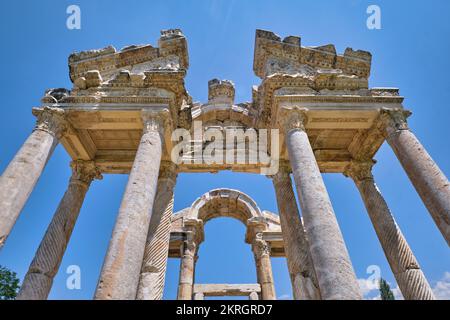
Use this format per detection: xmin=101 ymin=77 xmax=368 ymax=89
xmin=177 ymin=231 xmax=198 ymax=300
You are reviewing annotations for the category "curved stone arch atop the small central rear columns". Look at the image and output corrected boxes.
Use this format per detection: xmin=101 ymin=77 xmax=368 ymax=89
xmin=189 ymin=188 xmax=263 ymax=225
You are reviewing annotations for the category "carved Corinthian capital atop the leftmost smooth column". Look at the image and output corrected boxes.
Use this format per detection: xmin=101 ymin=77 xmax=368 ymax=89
xmin=32 ymin=107 xmax=70 ymax=139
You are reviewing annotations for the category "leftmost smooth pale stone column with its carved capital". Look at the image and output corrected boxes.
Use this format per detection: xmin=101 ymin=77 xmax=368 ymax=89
xmin=0 ymin=107 xmax=67 ymax=249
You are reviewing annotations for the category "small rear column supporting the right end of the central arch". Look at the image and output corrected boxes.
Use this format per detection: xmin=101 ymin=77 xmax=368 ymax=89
xmin=252 ymin=232 xmax=276 ymax=300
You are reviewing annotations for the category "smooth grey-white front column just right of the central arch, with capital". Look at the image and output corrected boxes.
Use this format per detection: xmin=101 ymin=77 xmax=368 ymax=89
xmin=283 ymin=110 xmax=362 ymax=300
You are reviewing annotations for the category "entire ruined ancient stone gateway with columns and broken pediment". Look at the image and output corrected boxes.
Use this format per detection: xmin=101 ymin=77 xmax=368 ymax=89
xmin=0 ymin=29 xmax=450 ymax=299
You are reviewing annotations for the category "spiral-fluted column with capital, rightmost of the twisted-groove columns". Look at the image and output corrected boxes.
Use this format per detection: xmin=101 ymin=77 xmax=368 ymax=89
xmin=345 ymin=161 xmax=434 ymax=300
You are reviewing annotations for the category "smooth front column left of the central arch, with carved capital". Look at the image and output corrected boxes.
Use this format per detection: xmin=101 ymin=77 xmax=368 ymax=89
xmin=95 ymin=111 xmax=168 ymax=300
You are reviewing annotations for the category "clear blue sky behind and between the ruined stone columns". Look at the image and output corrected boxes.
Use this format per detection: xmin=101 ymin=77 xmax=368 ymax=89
xmin=0 ymin=0 xmax=450 ymax=299
